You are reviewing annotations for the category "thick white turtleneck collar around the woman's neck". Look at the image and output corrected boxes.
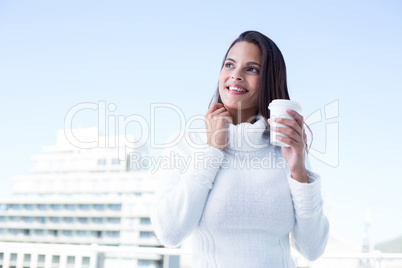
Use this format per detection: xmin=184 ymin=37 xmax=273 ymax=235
xmin=225 ymin=114 xmax=269 ymax=151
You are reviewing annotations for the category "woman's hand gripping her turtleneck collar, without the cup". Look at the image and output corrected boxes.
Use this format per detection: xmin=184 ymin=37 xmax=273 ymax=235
xmin=204 ymin=103 xmax=233 ymax=150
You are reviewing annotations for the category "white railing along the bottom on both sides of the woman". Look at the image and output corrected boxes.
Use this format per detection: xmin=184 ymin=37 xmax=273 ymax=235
xmin=0 ymin=242 xmax=402 ymax=268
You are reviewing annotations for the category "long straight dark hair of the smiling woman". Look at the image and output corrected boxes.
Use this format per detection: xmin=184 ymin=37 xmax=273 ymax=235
xmin=210 ymin=31 xmax=313 ymax=151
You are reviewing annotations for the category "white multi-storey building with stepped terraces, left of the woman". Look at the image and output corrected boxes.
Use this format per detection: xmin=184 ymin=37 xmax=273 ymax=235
xmin=0 ymin=129 xmax=171 ymax=267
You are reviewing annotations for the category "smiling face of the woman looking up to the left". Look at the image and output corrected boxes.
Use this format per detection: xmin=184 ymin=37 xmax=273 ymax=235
xmin=219 ymin=41 xmax=261 ymax=110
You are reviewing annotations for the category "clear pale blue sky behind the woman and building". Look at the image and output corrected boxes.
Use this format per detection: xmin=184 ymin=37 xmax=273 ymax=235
xmin=0 ymin=0 xmax=402 ymax=242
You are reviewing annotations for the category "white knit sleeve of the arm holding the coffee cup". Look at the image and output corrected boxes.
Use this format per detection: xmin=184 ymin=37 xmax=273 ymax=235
xmin=288 ymin=156 xmax=329 ymax=261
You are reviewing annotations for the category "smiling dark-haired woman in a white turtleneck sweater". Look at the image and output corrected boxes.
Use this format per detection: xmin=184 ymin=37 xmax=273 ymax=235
xmin=151 ymin=31 xmax=328 ymax=268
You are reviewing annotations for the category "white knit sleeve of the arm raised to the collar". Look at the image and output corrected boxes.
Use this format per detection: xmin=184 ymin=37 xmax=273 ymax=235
xmin=151 ymin=132 xmax=224 ymax=247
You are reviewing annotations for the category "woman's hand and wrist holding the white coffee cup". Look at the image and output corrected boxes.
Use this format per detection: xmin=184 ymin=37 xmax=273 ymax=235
xmin=268 ymin=110 xmax=308 ymax=182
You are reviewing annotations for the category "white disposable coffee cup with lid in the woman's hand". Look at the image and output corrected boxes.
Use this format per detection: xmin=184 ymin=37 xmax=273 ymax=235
xmin=268 ymin=99 xmax=302 ymax=147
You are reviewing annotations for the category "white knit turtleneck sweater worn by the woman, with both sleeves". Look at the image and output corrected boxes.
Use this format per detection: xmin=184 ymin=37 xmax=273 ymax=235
xmin=151 ymin=117 xmax=329 ymax=268
